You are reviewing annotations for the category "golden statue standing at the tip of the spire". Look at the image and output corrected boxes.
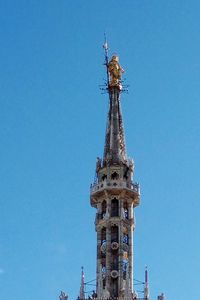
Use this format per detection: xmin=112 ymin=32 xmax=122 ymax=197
xmin=108 ymin=55 xmax=124 ymax=89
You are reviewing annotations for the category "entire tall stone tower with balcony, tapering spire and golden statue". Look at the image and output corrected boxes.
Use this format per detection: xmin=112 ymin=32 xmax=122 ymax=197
xmin=90 ymin=50 xmax=140 ymax=299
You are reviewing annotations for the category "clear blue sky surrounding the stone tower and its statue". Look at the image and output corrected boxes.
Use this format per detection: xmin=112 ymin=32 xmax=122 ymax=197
xmin=0 ymin=0 xmax=200 ymax=300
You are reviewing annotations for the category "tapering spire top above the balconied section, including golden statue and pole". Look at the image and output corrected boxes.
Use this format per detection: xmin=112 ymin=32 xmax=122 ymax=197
xmin=103 ymin=51 xmax=126 ymax=165
